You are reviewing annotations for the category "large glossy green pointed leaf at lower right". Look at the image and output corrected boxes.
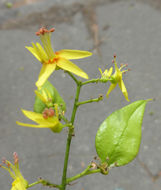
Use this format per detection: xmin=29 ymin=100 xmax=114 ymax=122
xmin=95 ymin=100 xmax=147 ymax=166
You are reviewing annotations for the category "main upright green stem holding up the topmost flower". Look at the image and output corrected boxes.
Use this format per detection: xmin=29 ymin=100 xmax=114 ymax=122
xmin=61 ymin=72 xmax=81 ymax=190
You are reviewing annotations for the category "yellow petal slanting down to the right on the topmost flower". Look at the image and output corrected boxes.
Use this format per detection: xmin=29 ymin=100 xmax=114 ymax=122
xmin=57 ymin=58 xmax=88 ymax=79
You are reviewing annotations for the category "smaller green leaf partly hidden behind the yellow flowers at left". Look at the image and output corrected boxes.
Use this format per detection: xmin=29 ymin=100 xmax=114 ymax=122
xmin=34 ymin=81 xmax=66 ymax=113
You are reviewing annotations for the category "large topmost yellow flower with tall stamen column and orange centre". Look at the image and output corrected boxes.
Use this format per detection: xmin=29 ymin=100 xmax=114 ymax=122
xmin=26 ymin=28 xmax=92 ymax=87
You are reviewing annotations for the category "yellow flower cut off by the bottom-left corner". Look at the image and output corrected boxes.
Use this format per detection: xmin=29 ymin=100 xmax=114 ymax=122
xmin=0 ymin=152 xmax=28 ymax=190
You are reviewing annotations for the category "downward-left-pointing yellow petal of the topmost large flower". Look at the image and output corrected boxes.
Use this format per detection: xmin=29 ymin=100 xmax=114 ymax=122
xmin=36 ymin=63 xmax=56 ymax=88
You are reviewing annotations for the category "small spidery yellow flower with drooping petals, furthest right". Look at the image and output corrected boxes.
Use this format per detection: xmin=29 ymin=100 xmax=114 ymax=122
xmin=106 ymin=55 xmax=130 ymax=101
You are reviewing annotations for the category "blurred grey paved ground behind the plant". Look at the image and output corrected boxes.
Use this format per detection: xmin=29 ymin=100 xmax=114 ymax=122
xmin=0 ymin=0 xmax=161 ymax=190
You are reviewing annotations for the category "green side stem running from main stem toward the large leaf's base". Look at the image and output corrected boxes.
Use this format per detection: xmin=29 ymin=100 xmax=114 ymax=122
xmin=67 ymin=167 xmax=101 ymax=184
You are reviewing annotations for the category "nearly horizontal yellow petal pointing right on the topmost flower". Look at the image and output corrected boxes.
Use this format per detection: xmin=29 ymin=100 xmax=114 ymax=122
xmin=56 ymin=49 xmax=92 ymax=59
